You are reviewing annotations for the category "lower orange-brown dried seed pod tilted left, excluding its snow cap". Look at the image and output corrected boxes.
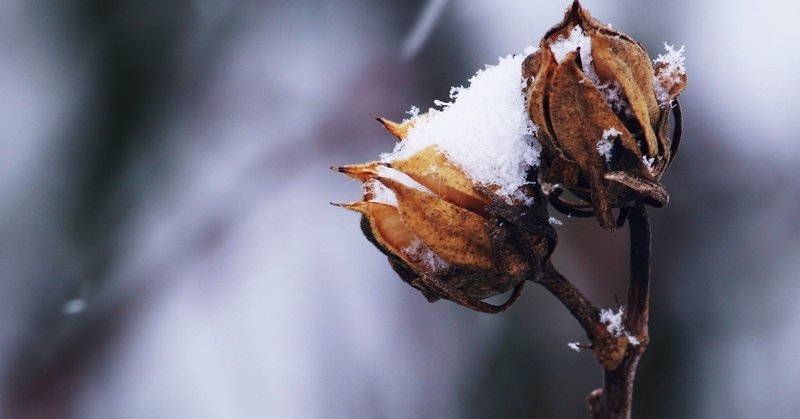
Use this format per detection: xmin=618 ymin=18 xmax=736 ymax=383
xmin=336 ymin=118 xmax=556 ymax=312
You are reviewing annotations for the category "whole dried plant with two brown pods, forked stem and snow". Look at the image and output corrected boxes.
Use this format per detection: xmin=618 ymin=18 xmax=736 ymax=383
xmin=334 ymin=1 xmax=686 ymax=419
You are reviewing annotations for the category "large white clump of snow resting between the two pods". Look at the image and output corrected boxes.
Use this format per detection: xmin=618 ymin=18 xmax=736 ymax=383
xmin=381 ymin=48 xmax=540 ymax=199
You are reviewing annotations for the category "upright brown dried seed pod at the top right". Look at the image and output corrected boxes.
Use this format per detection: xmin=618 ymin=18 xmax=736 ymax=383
xmin=522 ymin=1 xmax=686 ymax=230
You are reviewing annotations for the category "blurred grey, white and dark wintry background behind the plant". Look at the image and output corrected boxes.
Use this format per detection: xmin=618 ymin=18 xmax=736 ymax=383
xmin=0 ymin=0 xmax=800 ymax=419
